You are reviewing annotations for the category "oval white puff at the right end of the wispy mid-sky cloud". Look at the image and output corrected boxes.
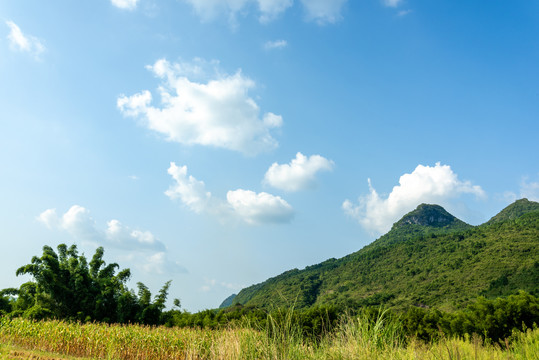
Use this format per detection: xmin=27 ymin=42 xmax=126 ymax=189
xmin=226 ymin=189 xmax=294 ymax=224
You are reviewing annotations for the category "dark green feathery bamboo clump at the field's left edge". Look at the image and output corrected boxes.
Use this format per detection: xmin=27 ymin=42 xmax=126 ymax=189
xmin=0 ymin=244 xmax=170 ymax=324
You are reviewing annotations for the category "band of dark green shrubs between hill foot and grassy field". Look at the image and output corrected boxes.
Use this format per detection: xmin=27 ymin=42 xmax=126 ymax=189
xmin=161 ymin=291 xmax=539 ymax=342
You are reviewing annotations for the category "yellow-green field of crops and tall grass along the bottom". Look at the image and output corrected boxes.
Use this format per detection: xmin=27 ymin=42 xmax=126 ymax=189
xmin=0 ymin=316 xmax=539 ymax=360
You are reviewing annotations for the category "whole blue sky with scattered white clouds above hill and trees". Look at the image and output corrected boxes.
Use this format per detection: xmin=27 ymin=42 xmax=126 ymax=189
xmin=0 ymin=0 xmax=539 ymax=311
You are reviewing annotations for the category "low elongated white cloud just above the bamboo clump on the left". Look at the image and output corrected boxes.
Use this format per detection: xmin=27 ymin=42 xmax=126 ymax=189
xmin=37 ymin=205 xmax=165 ymax=251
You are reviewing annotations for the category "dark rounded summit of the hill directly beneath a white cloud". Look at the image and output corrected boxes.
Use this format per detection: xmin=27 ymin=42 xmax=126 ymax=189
xmin=393 ymin=204 xmax=461 ymax=229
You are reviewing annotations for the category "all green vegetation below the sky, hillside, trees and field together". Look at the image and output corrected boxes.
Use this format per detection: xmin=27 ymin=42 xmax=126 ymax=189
xmin=0 ymin=199 xmax=539 ymax=359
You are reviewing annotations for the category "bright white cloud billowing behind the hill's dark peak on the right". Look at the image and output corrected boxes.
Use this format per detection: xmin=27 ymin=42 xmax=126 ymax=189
xmin=342 ymin=163 xmax=485 ymax=233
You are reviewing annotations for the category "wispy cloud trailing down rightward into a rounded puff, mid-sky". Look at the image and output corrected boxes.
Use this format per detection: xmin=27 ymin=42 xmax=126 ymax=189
xmin=165 ymin=162 xmax=294 ymax=225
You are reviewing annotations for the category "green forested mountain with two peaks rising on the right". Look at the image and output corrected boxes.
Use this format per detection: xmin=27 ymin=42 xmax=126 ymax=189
xmin=233 ymin=200 xmax=539 ymax=310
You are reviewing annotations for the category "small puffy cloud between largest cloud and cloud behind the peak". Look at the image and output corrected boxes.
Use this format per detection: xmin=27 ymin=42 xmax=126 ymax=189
xmin=264 ymin=152 xmax=334 ymax=191
